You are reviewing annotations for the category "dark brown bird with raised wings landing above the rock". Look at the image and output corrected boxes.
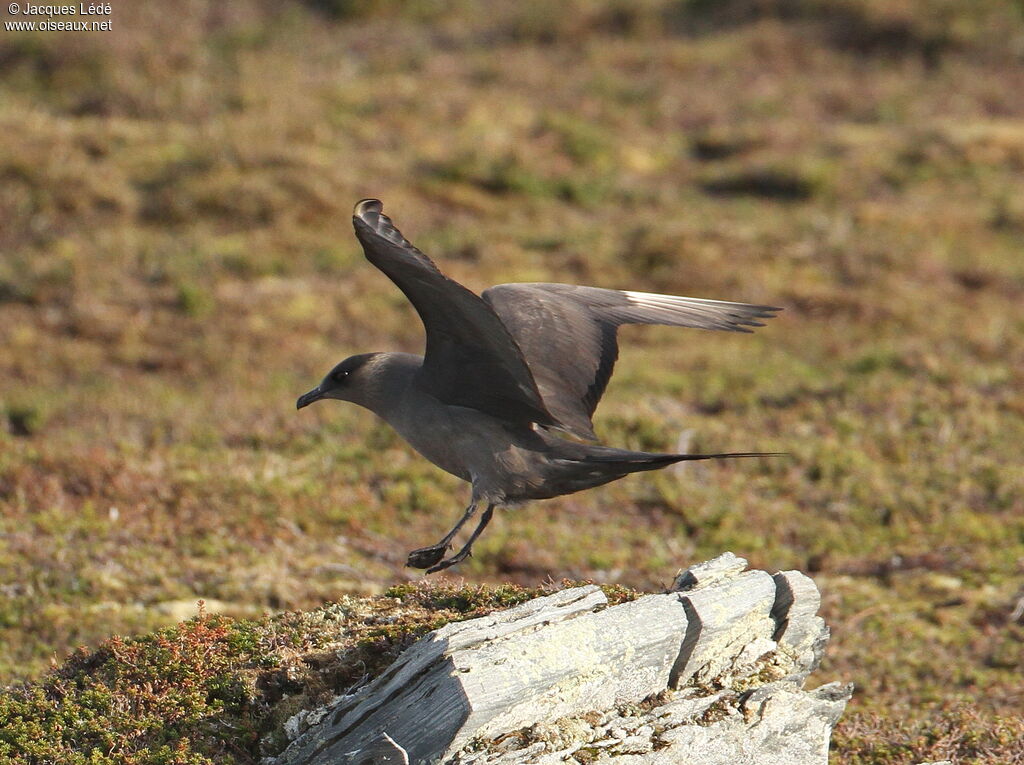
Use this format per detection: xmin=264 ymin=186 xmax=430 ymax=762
xmin=296 ymin=200 xmax=779 ymax=572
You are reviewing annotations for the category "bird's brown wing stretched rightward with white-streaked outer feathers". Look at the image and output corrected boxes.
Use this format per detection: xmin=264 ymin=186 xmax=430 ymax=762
xmin=481 ymin=284 xmax=780 ymax=438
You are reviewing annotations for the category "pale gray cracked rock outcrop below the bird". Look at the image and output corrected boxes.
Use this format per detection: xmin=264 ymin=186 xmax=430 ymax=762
xmin=265 ymin=553 xmax=852 ymax=765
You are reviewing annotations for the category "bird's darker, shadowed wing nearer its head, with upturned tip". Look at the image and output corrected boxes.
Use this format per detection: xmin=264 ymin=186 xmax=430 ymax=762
xmin=352 ymin=200 xmax=558 ymax=425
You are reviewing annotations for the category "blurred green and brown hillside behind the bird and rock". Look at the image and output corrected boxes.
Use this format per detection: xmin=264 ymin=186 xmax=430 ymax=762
xmin=0 ymin=0 xmax=1024 ymax=763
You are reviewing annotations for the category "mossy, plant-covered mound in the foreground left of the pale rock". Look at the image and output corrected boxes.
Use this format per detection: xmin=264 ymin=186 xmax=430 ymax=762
xmin=0 ymin=584 xmax=553 ymax=765
